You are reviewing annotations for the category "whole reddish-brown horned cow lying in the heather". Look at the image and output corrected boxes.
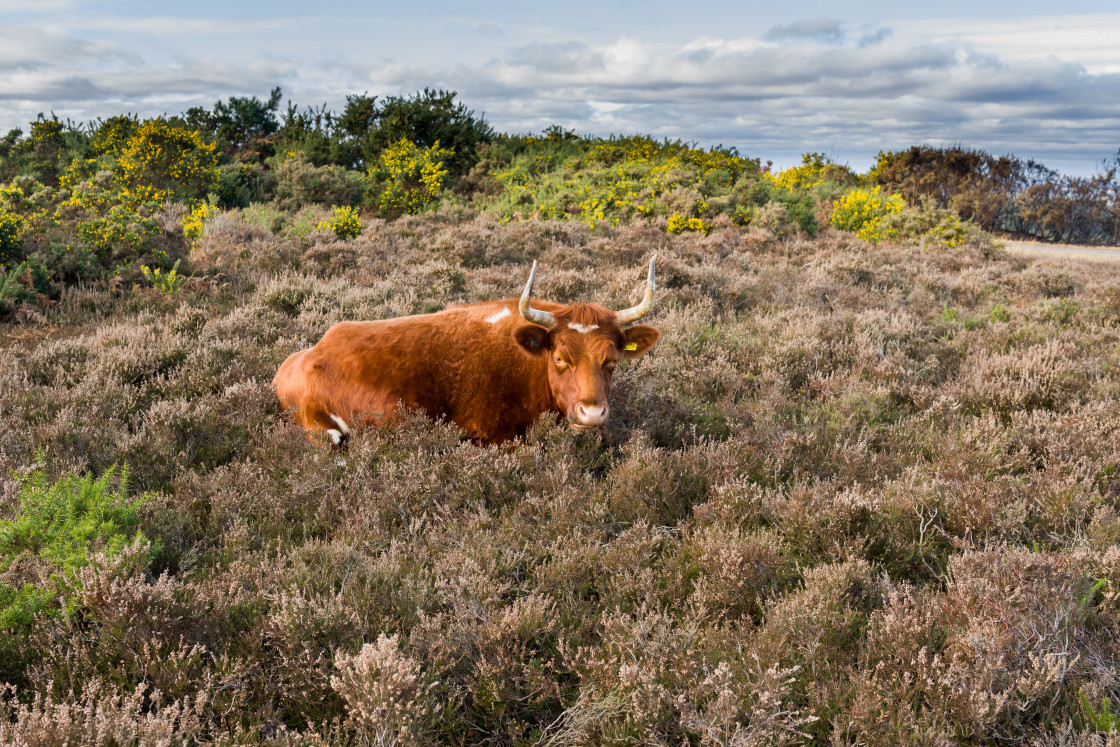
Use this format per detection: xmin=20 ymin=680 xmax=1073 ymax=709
xmin=272 ymin=260 xmax=661 ymax=446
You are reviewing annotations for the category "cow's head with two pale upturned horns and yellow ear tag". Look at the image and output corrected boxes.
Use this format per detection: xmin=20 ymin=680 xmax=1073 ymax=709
xmin=513 ymin=260 xmax=661 ymax=430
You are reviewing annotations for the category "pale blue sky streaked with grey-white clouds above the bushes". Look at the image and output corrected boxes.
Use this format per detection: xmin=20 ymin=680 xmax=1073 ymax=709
xmin=0 ymin=0 xmax=1120 ymax=175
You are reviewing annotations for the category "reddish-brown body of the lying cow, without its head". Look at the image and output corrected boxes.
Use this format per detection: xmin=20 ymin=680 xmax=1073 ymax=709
xmin=273 ymin=299 xmax=564 ymax=441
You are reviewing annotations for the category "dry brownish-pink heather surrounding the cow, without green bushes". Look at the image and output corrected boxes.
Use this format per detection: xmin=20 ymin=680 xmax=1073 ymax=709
xmin=0 ymin=209 xmax=1120 ymax=746
